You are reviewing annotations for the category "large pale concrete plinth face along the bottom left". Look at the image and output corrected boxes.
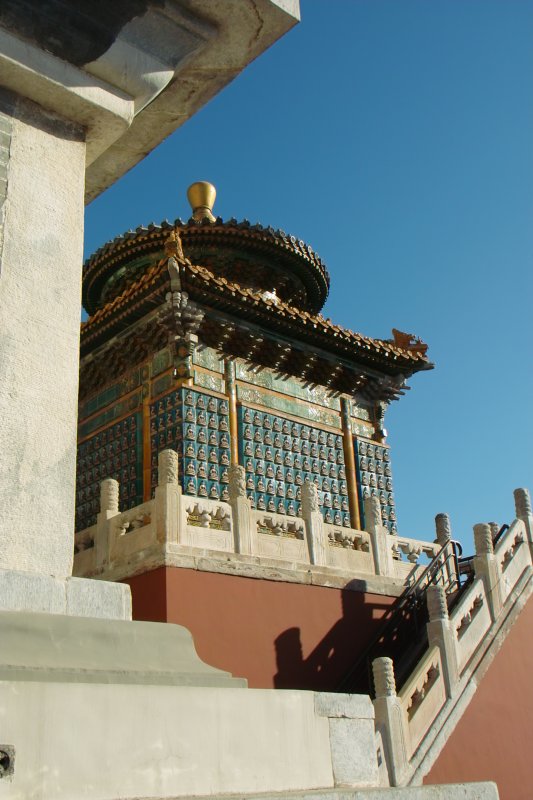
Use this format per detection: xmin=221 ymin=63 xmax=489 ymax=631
xmin=0 ymin=682 xmax=333 ymax=800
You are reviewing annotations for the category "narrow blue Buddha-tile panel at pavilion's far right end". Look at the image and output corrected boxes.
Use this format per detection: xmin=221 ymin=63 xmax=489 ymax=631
xmin=354 ymin=437 xmax=397 ymax=533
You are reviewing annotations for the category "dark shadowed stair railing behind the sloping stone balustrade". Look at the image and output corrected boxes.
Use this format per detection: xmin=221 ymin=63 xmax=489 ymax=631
xmin=337 ymin=540 xmax=462 ymax=696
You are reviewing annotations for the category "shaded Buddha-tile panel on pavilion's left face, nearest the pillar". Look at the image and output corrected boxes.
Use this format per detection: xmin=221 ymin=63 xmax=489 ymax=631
xmin=76 ymin=412 xmax=143 ymax=531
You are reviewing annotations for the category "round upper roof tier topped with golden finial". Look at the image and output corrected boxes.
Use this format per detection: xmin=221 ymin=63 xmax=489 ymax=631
xmin=83 ymin=181 xmax=329 ymax=314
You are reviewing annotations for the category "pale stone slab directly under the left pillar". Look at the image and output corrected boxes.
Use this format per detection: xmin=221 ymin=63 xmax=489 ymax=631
xmin=0 ymin=569 xmax=131 ymax=620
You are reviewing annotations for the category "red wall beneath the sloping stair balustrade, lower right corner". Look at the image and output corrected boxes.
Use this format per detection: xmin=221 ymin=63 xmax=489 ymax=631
xmin=424 ymin=598 xmax=533 ymax=800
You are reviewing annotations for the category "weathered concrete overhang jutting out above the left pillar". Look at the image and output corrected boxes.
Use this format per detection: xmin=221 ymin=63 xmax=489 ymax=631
xmin=0 ymin=0 xmax=299 ymax=202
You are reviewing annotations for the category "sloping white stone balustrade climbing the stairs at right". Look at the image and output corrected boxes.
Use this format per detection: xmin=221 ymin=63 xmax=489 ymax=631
xmin=373 ymin=489 xmax=533 ymax=786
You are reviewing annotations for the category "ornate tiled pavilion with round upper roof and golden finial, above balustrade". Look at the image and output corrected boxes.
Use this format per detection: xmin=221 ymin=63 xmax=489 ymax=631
xmin=76 ymin=182 xmax=432 ymax=534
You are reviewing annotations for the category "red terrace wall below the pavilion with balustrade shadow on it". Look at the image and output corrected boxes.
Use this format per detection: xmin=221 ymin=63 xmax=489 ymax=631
xmin=128 ymin=567 xmax=395 ymax=690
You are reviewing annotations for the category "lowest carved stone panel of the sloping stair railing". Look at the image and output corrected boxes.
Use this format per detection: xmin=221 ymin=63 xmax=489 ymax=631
xmin=398 ymin=647 xmax=446 ymax=757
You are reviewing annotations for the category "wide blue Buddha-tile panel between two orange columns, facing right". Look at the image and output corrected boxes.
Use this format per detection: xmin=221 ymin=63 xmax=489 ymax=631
xmin=239 ymin=406 xmax=350 ymax=527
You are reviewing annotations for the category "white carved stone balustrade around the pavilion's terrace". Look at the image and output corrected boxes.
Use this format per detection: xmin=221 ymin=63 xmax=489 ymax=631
xmin=74 ymin=450 xmax=440 ymax=586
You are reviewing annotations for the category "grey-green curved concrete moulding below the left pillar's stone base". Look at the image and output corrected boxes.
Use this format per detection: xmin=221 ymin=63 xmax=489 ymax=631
xmin=0 ymin=611 xmax=246 ymax=687
